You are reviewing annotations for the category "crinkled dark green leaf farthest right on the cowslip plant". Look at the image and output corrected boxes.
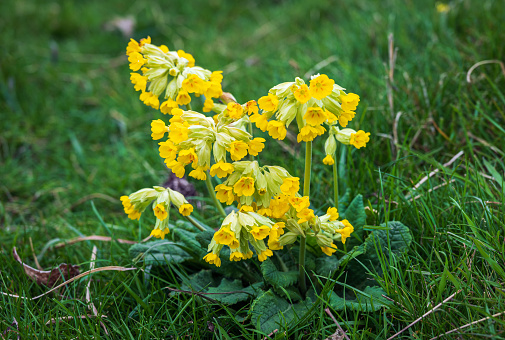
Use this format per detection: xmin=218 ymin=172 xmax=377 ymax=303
xmin=346 ymin=221 xmax=412 ymax=288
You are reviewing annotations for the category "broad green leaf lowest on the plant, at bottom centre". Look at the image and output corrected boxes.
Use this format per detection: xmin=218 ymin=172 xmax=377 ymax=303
xmin=249 ymin=290 xmax=313 ymax=334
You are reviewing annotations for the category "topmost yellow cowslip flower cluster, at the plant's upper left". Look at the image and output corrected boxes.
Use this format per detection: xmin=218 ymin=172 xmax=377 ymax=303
xmin=126 ymin=37 xmax=223 ymax=114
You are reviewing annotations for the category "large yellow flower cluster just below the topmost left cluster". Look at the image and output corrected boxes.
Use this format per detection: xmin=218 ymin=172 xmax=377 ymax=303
xmin=151 ymin=108 xmax=265 ymax=180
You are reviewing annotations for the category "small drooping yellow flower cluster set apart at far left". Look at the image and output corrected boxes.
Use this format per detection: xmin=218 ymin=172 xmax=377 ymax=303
xmin=120 ymin=186 xmax=193 ymax=239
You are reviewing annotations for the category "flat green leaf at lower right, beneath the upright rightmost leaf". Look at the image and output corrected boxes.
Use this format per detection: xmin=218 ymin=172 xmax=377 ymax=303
xmin=329 ymin=287 xmax=390 ymax=312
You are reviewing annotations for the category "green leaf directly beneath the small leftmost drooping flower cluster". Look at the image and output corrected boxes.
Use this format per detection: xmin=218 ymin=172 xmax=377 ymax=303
xmin=129 ymin=240 xmax=192 ymax=265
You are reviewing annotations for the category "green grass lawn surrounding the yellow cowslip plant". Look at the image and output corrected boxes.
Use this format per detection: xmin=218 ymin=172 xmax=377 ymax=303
xmin=0 ymin=0 xmax=505 ymax=339
